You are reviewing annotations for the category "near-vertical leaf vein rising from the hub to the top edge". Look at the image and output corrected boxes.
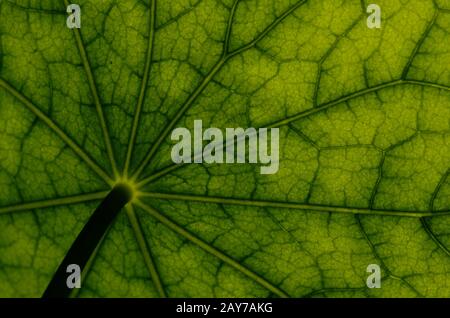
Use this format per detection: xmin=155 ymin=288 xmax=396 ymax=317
xmin=123 ymin=0 xmax=156 ymax=177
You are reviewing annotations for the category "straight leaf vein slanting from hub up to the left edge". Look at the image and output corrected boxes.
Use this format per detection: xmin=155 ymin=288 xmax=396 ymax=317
xmin=0 ymin=78 xmax=113 ymax=185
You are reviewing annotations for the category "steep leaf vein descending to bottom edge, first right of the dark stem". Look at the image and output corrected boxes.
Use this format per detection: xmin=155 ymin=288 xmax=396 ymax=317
xmin=126 ymin=205 xmax=167 ymax=297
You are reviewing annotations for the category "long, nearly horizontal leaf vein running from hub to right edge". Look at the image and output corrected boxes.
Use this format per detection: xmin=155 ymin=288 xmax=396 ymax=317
xmin=141 ymin=192 xmax=450 ymax=218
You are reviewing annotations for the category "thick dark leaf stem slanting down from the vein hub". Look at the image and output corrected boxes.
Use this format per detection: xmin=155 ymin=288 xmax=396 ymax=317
xmin=42 ymin=184 xmax=132 ymax=298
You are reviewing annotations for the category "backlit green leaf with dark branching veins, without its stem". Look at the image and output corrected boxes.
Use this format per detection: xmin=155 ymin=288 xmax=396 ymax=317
xmin=0 ymin=0 xmax=450 ymax=297
